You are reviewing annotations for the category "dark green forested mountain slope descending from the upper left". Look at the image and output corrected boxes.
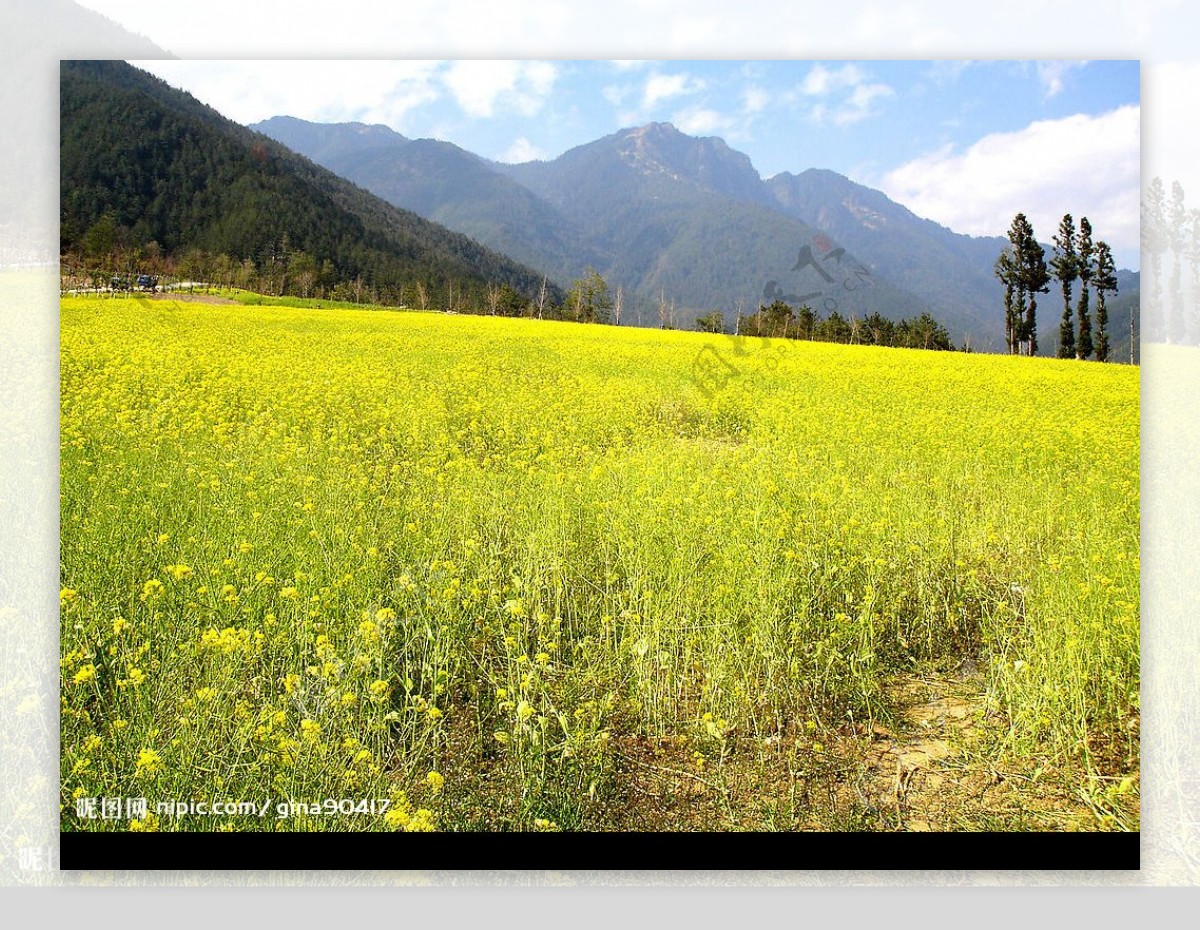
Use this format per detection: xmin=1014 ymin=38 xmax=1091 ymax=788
xmin=60 ymin=61 xmax=560 ymax=309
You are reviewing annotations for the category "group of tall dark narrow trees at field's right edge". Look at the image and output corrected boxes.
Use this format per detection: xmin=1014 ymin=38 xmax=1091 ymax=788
xmin=996 ymin=214 xmax=1118 ymax=361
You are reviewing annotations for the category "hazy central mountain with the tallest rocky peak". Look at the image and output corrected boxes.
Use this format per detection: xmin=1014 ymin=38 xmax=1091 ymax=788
xmin=496 ymin=122 xmax=922 ymax=319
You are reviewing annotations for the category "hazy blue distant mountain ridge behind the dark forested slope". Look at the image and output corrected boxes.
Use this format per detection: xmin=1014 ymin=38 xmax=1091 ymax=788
xmin=252 ymin=116 xmax=1136 ymax=352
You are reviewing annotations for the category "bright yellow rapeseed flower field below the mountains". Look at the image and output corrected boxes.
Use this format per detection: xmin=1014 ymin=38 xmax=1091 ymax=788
xmin=60 ymin=298 xmax=1139 ymax=830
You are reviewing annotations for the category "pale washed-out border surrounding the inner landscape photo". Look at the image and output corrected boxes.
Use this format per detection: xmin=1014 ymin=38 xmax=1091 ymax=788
xmin=0 ymin=0 xmax=1200 ymax=907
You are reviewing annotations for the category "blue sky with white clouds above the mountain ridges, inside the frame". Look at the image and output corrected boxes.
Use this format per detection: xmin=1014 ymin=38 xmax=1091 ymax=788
xmin=124 ymin=60 xmax=1140 ymax=268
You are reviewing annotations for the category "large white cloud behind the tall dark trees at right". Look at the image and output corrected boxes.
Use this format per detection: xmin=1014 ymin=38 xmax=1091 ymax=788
xmin=877 ymin=106 xmax=1140 ymax=268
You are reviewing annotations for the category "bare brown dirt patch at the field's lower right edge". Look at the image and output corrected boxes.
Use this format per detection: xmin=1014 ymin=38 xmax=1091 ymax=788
xmin=605 ymin=662 xmax=1132 ymax=832
